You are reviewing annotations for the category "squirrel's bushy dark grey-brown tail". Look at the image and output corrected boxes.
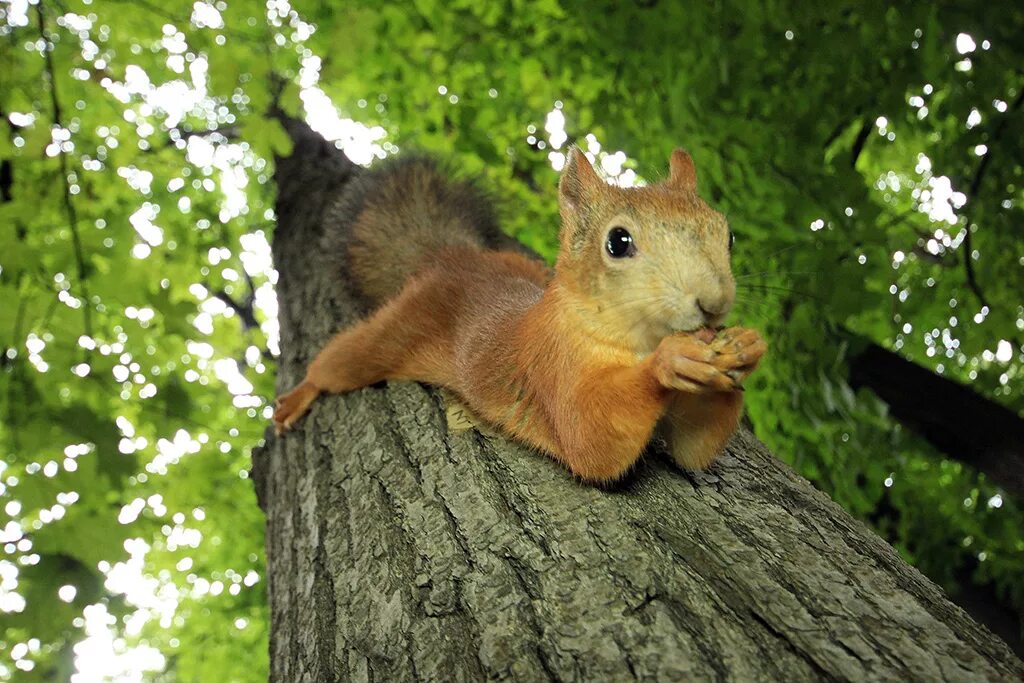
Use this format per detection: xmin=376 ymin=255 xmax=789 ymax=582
xmin=325 ymin=156 xmax=503 ymax=305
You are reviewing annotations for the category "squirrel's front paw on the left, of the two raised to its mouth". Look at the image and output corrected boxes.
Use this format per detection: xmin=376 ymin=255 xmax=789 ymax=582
xmin=652 ymin=335 xmax=738 ymax=393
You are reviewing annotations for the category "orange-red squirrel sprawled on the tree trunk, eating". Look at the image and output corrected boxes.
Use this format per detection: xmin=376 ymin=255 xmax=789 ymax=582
xmin=273 ymin=147 xmax=767 ymax=483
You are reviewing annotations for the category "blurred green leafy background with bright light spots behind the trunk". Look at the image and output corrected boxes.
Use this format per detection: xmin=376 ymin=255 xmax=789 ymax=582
xmin=0 ymin=0 xmax=1024 ymax=682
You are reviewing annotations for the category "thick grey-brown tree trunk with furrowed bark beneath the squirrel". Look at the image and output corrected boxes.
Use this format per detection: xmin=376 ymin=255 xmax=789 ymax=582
xmin=254 ymin=121 xmax=1024 ymax=682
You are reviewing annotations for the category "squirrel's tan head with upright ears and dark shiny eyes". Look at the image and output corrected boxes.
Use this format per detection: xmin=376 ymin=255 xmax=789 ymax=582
xmin=557 ymin=147 xmax=736 ymax=352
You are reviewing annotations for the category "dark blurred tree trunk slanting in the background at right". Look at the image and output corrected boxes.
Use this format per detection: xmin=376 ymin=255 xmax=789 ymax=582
xmin=850 ymin=337 xmax=1024 ymax=503
